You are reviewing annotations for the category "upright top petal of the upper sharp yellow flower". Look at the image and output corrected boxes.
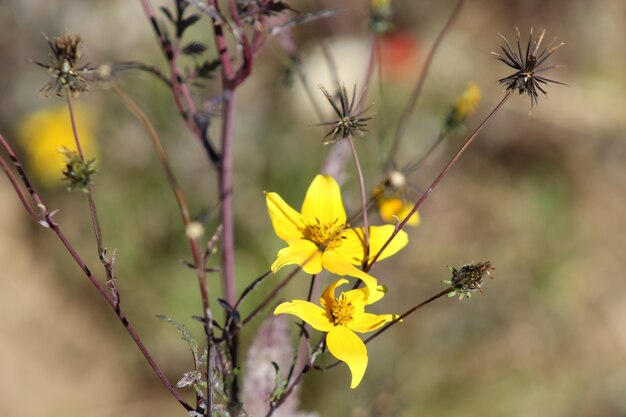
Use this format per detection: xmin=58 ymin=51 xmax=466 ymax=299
xmin=302 ymin=175 xmax=346 ymax=225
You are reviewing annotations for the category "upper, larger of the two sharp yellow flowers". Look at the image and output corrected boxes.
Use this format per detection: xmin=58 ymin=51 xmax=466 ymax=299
xmin=266 ymin=175 xmax=408 ymax=302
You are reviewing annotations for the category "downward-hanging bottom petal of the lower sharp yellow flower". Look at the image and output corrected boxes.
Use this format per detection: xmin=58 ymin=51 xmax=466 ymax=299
xmin=326 ymin=326 xmax=367 ymax=388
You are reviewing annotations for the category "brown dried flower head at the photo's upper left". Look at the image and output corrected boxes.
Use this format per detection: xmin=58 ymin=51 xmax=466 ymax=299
xmin=35 ymin=32 xmax=93 ymax=96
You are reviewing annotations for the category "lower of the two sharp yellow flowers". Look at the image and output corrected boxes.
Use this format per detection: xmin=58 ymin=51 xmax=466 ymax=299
xmin=274 ymin=279 xmax=396 ymax=388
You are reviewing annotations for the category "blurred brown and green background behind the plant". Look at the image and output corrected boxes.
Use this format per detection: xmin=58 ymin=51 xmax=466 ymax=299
xmin=0 ymin=0 xmax=626 ymax=417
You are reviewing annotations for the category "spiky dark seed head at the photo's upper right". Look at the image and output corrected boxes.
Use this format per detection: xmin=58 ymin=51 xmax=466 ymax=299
xmin=492 ymin=27 xmax=565 ymax=107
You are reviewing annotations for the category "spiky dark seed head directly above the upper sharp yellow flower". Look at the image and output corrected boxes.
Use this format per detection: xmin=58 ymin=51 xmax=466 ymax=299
xmin=320 ymin=85 xmax=372 ymax=143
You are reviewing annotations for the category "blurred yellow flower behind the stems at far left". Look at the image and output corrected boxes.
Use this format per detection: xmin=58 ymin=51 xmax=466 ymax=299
xmin=18 ymin=106 xmax=97 ymax=185
